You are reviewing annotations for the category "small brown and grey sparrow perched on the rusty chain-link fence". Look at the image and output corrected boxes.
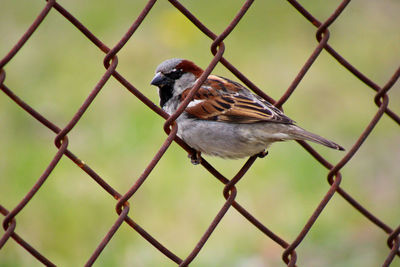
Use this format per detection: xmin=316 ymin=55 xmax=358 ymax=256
xmin=151 ymin=58 xmax=344 ymax=164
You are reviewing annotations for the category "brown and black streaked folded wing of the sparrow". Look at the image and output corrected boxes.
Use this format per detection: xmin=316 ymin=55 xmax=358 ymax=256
xmin=181 ymin=75 xmax=293 ymax=123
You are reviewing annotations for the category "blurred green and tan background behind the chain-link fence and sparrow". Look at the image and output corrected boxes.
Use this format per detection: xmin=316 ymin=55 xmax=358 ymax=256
xmin=0 ymin=0 xmax=400 ymax=266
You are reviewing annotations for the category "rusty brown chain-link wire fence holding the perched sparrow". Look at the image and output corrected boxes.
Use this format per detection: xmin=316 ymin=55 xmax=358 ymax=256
xmin=0 ymin=0 xmax=400 ymax=266
